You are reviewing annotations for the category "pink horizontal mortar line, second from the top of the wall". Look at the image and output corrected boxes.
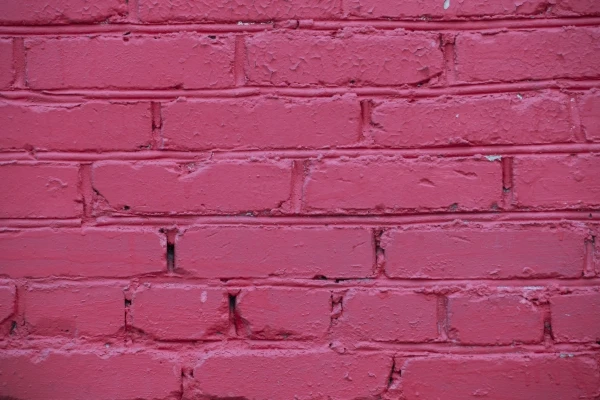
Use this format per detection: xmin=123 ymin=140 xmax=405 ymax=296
xmin=0 ymin=79 xmax=600 ymax=102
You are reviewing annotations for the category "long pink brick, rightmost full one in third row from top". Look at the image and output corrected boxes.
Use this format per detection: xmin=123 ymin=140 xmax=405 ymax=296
xmin=372 ymin=92 xmax=575 ymax=147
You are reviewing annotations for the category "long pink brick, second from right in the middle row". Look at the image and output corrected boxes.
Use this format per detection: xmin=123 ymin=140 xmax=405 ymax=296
xmin=304 ymin=157 xmax=502 ymax=213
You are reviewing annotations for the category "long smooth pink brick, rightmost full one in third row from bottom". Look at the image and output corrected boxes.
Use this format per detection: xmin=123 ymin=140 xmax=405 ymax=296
xmin=382 ymin=226 xmax=586 ymax=279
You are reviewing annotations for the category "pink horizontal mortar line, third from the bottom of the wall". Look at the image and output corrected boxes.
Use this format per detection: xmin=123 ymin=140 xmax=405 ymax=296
xmin=0 ymin=210 xmax=600 ymax=229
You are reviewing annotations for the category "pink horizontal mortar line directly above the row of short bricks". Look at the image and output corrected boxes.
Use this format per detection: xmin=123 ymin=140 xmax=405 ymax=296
xmin=10 ymin=273 xmax=600 ymax=288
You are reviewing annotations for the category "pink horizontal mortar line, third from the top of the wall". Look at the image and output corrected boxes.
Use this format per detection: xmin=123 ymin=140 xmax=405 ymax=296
xmin=0 ymin=143 xmax=600 ymax=163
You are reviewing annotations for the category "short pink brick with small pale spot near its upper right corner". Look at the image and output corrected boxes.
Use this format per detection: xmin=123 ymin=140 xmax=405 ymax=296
xmin=131 ymin=284 xmax=229 ymax=340
